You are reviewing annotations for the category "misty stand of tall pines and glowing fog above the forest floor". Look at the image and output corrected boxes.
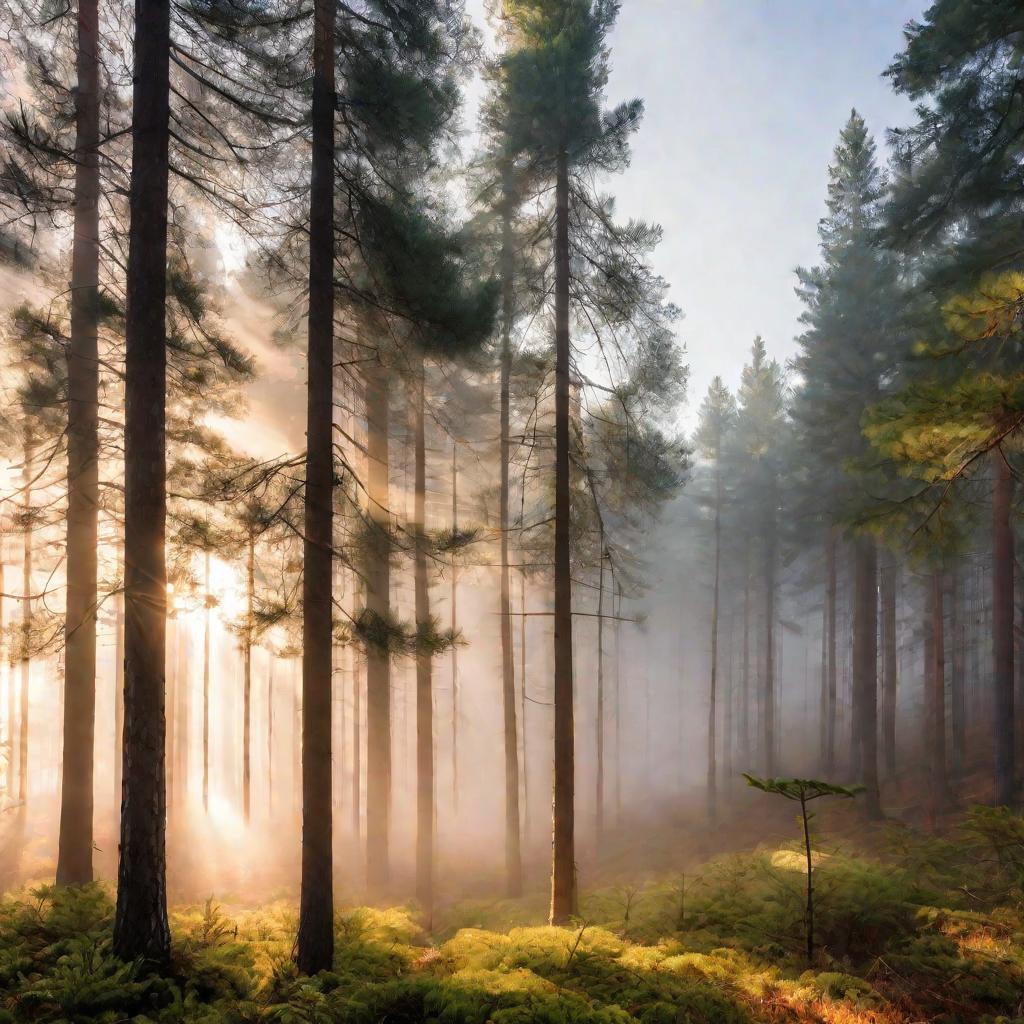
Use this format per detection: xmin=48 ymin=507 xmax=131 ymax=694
xmin=0 ymin=0 xmax=1024 ymax=973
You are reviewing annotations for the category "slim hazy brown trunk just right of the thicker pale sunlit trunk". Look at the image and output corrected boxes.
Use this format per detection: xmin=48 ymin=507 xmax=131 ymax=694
xmin=413 ymin=366 xmax=434 ymax=931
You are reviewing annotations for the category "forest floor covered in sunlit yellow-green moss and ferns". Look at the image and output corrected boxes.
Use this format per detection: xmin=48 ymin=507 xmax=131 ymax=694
xmin=0 ymin=808 xmax=1024 ymax=1024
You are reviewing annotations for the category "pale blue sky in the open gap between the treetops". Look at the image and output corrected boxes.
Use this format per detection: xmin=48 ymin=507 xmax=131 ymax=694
xmin=467 ymin=0 xmax=926 ymax=427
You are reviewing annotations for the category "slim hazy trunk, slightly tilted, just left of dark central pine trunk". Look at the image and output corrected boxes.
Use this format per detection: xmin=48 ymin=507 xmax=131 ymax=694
xmin=499 ymin=182 xmax=524 ymax=898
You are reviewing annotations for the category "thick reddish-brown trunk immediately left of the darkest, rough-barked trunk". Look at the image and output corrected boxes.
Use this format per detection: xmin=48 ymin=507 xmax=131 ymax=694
xmin=56 ymin=0 xmax=99 ymax=885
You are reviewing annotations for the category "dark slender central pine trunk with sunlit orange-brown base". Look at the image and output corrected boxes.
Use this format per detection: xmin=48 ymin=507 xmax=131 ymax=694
xmin=550 ymin=146 xmax=577 ymax=925
